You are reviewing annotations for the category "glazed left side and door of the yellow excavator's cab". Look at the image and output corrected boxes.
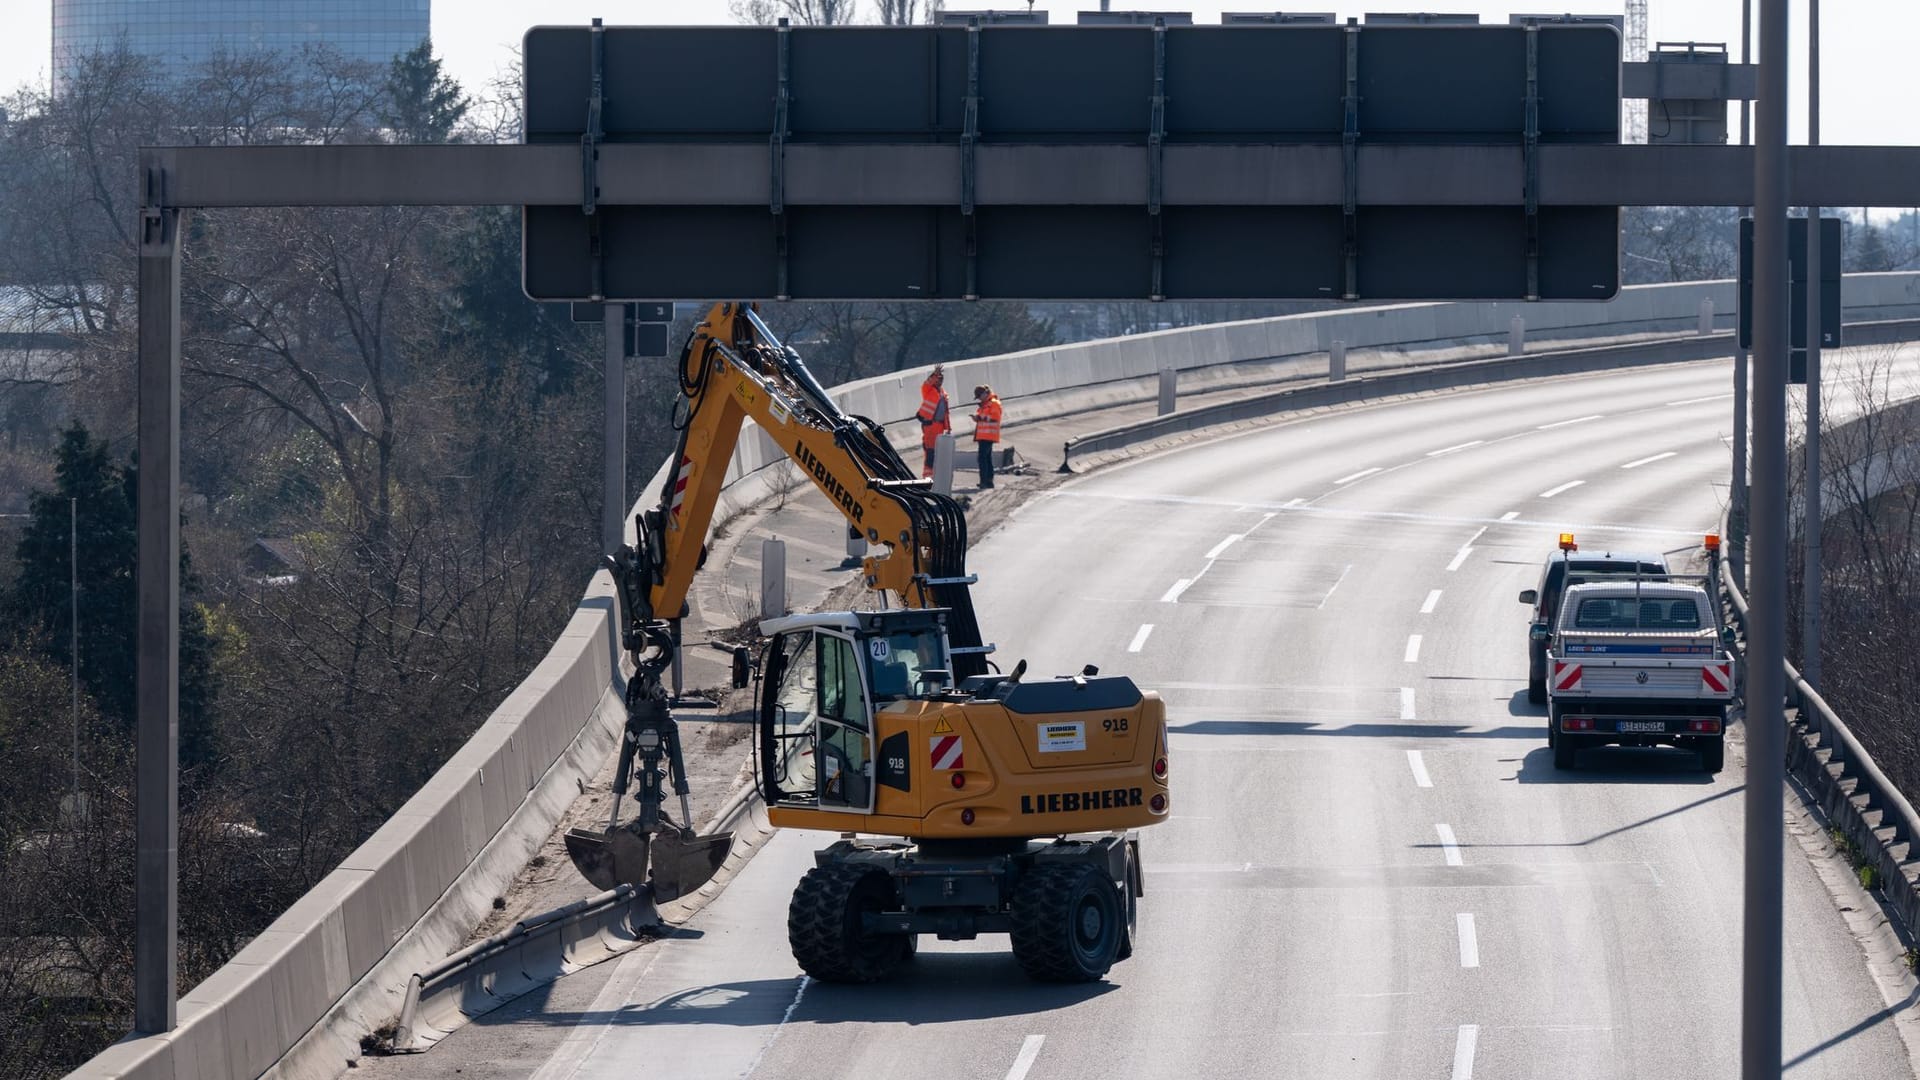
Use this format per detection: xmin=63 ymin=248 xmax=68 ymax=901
xmin=760 ymin=628 xmax=874 ymax=813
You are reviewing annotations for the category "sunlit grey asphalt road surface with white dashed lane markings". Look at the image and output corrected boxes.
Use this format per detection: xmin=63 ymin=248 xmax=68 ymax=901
xmin=369 ymin=361 xmax=1914 ymax=1080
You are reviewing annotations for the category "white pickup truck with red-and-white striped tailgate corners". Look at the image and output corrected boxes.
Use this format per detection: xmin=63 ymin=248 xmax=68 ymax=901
xmin=1548 ymin=578 xmax=1736 ymax=773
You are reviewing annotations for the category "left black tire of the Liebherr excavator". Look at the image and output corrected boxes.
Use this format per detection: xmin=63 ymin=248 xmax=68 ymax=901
xmin=787 ymin=867 xmax=914 ymax=982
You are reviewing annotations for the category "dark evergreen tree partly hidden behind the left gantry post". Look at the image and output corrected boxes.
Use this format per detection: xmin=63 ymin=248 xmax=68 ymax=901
xmin=6 ymin=421 xmax=217 ymax=767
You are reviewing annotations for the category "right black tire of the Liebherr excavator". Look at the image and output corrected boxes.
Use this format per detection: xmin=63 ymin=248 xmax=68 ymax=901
xmin=1010 ymin=865 xmax=1127 ymax=982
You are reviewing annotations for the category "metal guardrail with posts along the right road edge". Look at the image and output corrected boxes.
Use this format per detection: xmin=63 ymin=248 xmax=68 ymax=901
xmin=1716 ymin=511 xmax=1920 ymax=928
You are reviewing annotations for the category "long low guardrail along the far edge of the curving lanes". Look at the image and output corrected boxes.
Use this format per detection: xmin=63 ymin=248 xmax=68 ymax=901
xmin=1060 ymin=319 xmax=1920 ymax=473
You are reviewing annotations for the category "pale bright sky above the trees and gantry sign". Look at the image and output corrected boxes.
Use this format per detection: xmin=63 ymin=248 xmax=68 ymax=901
xmin=0 ymin=0 xmax=1920 ymax=146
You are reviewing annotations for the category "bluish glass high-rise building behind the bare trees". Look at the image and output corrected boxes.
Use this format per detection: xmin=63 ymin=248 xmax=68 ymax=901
xmin=52 ymin=0 xmax=432 ymax=94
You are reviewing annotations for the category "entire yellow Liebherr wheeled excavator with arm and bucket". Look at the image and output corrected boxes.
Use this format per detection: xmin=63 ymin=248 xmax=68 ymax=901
xmin=566 ymin=304 xmax=1171 ymax=982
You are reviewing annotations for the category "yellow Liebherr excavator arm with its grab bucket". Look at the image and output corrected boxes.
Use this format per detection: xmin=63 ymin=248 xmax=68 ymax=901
xmin=566 ymin=302 xmax=991 ymax=899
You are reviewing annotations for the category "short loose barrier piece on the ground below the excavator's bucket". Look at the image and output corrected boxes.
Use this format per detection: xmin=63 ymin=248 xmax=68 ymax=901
xmin=392 ymin=884 xmax=660 ymax=1053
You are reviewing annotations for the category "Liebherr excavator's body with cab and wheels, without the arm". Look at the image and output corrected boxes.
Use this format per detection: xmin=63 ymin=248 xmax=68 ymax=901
xmin=756 ymin=609 xmax=1169 ymax=982
